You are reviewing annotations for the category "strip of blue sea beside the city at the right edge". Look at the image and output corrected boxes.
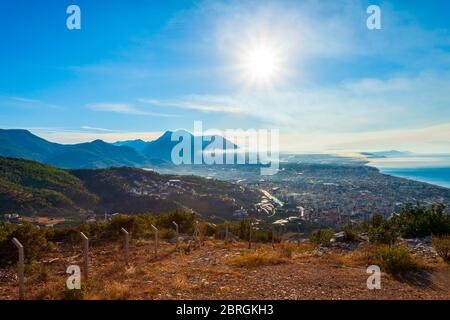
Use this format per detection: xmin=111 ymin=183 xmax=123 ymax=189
xmin=368 ymin=155 xmax=450 ymax=188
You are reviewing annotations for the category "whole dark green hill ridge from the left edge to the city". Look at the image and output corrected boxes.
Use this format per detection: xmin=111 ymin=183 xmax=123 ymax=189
xmin=0 ymin=157 xmax=260 ymax=221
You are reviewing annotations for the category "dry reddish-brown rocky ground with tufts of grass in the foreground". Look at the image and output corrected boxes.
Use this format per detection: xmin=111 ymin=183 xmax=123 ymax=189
xmin=0 ymin=240 xmax=450 ymax=300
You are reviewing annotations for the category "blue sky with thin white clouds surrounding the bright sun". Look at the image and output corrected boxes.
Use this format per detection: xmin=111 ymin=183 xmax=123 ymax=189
xmin=0 ymin=0 xmax=450 ymax=153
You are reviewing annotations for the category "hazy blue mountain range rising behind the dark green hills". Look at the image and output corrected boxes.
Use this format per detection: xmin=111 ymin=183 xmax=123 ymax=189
xmin=0 ymin=129 xmax=237 ymax=168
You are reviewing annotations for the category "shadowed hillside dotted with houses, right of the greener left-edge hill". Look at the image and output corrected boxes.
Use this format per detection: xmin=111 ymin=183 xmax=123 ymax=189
xmin=70 ymin=167 xmax=260 ymax=221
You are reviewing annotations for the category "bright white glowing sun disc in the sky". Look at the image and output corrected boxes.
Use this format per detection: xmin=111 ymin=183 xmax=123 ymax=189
xmin=242 ymin=44 xmax=281 ymax=84
